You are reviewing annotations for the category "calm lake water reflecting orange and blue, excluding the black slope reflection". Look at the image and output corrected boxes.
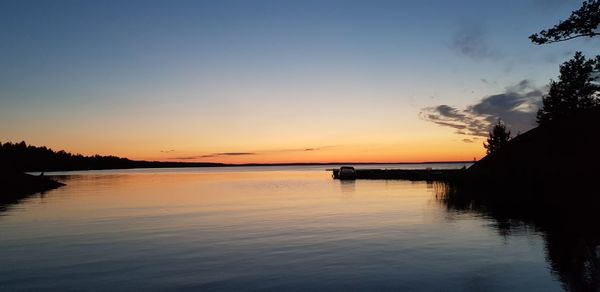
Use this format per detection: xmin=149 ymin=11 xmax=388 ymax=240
xmin=0 ymin=165 xmax=562 ymax=291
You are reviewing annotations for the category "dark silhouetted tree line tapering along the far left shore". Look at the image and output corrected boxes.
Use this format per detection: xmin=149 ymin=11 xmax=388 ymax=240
xmin=0 ymin=141 xmax=222 ymax=172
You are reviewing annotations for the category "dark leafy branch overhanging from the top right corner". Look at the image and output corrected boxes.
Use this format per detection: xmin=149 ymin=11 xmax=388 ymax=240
xmin=529 ymin=0 xmax=600 ymax=45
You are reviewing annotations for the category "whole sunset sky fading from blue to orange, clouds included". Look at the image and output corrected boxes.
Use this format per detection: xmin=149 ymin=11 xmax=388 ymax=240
xmin=0 ymin=0 xmax=600 ymax=163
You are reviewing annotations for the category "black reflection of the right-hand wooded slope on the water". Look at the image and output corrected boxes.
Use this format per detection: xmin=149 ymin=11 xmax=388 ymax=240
xmin=436 ymin=183 xmax=600 ymax=291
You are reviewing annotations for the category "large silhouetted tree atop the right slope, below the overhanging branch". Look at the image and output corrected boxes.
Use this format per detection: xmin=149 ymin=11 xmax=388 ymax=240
xmin=537 ymin=52 xmax=600 ymax=125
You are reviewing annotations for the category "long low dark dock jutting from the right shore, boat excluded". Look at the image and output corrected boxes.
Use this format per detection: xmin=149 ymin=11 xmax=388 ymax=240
xmin=327 ymin=169 xmax=465 ymax=181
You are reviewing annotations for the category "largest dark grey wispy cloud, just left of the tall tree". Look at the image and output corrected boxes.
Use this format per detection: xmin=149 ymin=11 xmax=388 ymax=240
xmin=420 ymin=80 xmax=547 ymax=143
